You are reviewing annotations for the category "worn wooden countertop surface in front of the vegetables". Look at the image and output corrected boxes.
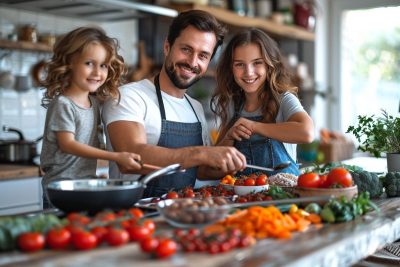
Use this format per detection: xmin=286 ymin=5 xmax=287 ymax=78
xmin=0 ymin=198 xmax=400 ymax=267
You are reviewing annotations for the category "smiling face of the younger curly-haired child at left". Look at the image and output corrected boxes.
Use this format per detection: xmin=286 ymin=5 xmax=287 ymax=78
xmin=68 ymin=42 xmax=108 ymax=96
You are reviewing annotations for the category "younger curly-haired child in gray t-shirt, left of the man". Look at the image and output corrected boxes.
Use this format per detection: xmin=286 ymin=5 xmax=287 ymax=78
xmin=40 ymin=27 xmax=140 ymax=206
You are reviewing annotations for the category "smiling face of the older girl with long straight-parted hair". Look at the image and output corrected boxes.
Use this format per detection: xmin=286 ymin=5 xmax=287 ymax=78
xmin=232 ymin=43 xmax=267 ymax=98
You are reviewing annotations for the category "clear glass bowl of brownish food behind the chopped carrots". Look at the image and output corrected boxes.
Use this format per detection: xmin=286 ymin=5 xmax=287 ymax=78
xmin=157 ymin=197 xmax=230 ymax=228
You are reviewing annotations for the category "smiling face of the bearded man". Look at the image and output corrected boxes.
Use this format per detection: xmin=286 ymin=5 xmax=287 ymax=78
xmin=164 ymin=26 xmax=217 ymax=89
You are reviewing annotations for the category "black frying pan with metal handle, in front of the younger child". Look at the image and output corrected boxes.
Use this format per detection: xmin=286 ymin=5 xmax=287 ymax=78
xmin=46 ymin=164 xmax=184 ymax=213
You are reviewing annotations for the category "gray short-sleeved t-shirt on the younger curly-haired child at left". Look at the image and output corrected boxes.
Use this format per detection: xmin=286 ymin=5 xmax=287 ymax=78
xmin=40 ymin=96 xmax=101 ymax=184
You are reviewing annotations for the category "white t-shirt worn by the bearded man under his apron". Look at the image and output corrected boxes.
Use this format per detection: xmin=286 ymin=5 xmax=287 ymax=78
xmin=102 ymin=79 xmax=210 ymax=181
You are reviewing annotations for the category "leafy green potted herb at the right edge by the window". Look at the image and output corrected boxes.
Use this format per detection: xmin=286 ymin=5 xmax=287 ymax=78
xmin=347 ymin=110 xmax=400 ymax=171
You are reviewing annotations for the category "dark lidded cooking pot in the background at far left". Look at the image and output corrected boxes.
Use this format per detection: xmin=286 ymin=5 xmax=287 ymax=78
xmin=0 ymin=125 xmax=42 ymax=163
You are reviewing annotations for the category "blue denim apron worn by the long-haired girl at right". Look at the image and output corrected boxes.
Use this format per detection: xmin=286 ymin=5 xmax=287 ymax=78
xmin=232 ymin=104 xmax=300 ymax=176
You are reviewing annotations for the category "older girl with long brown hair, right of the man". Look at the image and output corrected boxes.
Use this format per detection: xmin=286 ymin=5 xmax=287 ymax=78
xmin=211 ymin=28 xmax=314 ymax=175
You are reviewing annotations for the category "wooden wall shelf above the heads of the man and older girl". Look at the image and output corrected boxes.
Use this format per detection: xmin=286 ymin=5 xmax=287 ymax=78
xmin=171 ymin=4 xmax=315 ymax=41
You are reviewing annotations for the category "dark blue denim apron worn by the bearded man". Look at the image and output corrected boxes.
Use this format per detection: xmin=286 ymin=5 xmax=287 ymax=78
xmin=143 ymin=75 xmax=203 ymax=198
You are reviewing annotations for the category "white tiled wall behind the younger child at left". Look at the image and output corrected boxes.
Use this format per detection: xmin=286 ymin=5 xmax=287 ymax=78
xmin=0 ymin=7 xmax=137 ymax=140
